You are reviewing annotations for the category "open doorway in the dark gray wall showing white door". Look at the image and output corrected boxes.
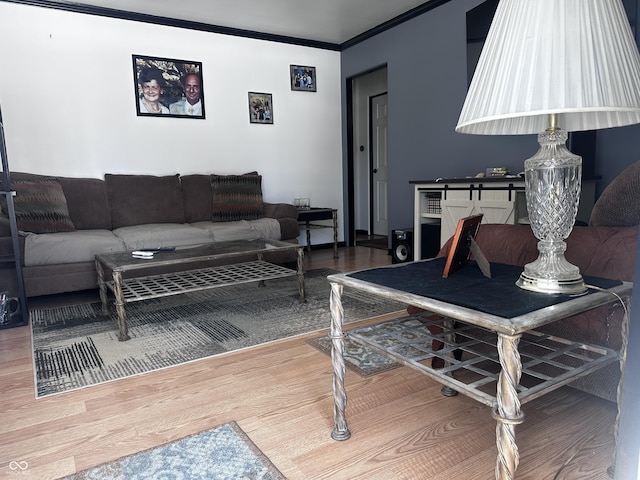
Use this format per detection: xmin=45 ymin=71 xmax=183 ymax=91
xmin=347 ymin=66 xmax=389 ymax=248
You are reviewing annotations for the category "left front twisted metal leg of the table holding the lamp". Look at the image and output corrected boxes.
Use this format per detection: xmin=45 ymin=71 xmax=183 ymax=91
xmin=329 ymin=283 xmax=351 ymax=440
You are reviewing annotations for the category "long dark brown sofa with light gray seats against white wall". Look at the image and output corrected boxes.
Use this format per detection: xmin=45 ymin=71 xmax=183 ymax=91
xmin=0 ymin=172 xmax=300 ymax=297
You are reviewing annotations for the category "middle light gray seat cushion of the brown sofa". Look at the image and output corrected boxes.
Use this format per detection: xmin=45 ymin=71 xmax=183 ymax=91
xmin=113 ymin=223 xmax=213 ymax=250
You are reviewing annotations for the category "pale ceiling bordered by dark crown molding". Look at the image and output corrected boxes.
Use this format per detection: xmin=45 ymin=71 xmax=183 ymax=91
xmin=37 ymin=0 xmax=442 ymax=46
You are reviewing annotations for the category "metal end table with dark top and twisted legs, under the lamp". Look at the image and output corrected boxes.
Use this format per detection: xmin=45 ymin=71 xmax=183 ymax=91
xmin=328 ymin=258 xmax=633 ymax=479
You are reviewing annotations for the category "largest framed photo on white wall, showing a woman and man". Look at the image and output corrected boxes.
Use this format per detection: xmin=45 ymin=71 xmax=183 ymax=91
xmin=132 ymin=55 xmax=205 ymax=119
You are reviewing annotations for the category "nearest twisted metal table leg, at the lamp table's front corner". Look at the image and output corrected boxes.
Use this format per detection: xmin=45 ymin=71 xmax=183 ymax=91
xmin=493 ymin=334 xmax=524 ymax=480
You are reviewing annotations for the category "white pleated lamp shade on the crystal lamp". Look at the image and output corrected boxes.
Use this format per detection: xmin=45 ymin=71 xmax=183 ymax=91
xmin=456 ymin=0 xmax=640 ymax=135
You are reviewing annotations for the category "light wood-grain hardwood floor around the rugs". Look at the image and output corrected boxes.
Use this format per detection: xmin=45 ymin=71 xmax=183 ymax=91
xmin=0 ymin=247 xmax=616 ymax=480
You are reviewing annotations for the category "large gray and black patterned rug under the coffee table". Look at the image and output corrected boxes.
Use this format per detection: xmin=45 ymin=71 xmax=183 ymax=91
xmin=30 ymin=269 xmax=405 ymax=397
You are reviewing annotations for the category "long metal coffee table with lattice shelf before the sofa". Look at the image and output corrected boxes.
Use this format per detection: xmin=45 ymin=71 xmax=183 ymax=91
xmin=95 ymin=239 xmax=305 ymax=342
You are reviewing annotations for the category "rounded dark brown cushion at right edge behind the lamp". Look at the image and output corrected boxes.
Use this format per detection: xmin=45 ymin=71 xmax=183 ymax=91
xmin=589 ymin=161 xmax=640 ymax=227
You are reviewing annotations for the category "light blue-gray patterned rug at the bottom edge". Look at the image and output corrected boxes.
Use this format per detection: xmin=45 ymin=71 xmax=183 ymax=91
xmin=62 ymin=422 xmax=285 ymax=480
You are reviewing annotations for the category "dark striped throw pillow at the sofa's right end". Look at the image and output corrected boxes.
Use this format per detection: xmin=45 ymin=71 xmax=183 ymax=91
xmin=211 ymin=175 xmax=264 ymax=222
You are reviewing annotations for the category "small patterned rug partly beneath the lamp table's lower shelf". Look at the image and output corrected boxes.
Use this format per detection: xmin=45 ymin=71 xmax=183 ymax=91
xmin=307 ymin=335 xmax=402 ymax=378
